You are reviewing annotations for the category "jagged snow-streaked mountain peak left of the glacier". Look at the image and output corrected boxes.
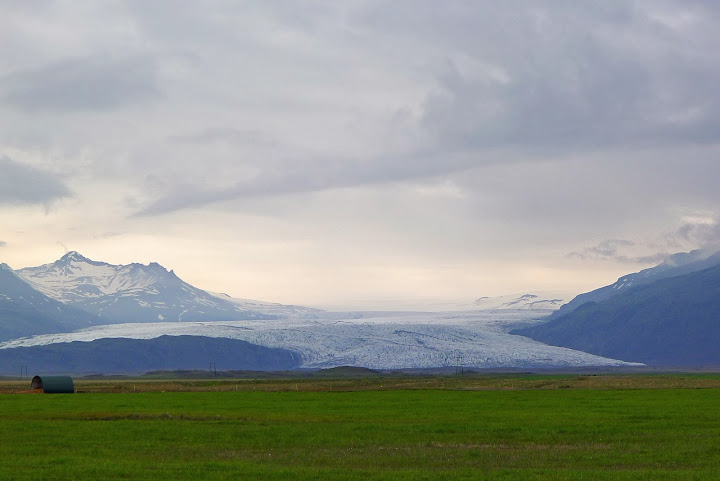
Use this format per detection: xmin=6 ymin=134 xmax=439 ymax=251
xmin=16 ymin=251 xmax=275 ymax=323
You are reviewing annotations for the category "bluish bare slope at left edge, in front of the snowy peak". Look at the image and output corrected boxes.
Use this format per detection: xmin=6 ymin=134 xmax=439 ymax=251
xmin=0 ymin=264 xmax=100 ymax=340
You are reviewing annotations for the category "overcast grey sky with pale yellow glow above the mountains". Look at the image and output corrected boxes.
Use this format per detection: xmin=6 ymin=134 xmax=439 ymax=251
xmin=0 ymin=0 xmax=720 ymax=308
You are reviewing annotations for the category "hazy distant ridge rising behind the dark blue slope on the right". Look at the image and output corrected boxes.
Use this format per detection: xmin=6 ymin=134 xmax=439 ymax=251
xmin=549 ymin=250 xmax=720 ymax=319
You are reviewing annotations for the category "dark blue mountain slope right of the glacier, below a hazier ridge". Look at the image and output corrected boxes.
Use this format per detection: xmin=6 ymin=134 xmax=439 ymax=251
xmin=511 ymin=265 xmax=720 ymax=367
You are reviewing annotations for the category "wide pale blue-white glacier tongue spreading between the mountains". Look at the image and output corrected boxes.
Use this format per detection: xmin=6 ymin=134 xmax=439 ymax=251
xmin=0 ymin=310 xmax=630 ymax=369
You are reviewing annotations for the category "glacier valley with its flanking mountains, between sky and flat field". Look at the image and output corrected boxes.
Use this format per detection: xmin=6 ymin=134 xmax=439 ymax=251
xmin=0 ymin=252 xmax=720 ymax=374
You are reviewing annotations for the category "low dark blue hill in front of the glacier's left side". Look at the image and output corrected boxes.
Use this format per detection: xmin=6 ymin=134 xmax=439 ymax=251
xmin=0 ymin=336 xmax=301 ymax=374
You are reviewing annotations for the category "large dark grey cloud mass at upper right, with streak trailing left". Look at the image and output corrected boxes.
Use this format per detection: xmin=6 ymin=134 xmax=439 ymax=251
xmin=143 ymin=0 xmax=720 ymax=215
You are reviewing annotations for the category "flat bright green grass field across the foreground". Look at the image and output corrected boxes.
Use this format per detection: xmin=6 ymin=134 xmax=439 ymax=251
xmin=0 ymin=376 xmax=720 ymax=480
